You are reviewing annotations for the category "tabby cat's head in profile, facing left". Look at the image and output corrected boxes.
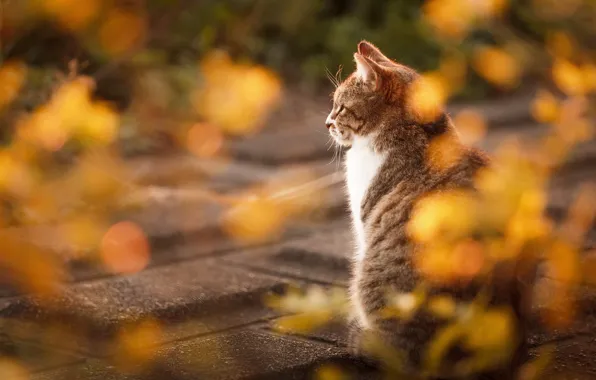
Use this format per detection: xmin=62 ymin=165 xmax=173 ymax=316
xmin=325 ymin=41 xmax=434 ymax=146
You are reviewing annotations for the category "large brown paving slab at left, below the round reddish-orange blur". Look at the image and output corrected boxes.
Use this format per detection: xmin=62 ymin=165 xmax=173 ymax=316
xmin=0 ymin=260 xmax=285 ymax=352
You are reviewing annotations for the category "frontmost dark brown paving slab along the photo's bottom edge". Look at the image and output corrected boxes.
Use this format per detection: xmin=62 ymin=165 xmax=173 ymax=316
xmin=33 ymin=329 xmax=346 ymax=380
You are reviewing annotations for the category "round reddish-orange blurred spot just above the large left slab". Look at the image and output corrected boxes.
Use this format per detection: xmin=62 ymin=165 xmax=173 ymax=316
xmin=100 ymin=221 xmax=150 ymax=273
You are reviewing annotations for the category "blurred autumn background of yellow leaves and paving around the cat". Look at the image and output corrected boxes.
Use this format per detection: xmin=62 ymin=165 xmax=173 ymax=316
xmin=0 ymin=0 xmax=596 ymax=380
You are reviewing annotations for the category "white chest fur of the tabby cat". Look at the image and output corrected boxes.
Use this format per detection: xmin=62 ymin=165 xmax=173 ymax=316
xmin=346 ymin=137 xmax=385 ymax=261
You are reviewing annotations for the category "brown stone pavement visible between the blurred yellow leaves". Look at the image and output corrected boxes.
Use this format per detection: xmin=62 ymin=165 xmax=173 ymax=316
xmin=0 ymin=87 xmax=596 ymax=380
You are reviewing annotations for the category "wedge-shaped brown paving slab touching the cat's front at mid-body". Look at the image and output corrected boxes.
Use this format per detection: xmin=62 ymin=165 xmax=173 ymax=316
xmin=222 ymin=221 xmax=353 ymax=285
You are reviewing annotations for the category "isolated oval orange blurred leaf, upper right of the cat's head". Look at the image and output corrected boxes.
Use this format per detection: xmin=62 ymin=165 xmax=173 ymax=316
xmin=472 ymin=47 xmax=521 ymax=88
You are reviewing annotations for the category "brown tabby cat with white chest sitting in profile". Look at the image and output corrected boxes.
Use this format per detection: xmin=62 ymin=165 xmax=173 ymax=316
xmin=325 ymin=41 xmax=527 ymax=379
